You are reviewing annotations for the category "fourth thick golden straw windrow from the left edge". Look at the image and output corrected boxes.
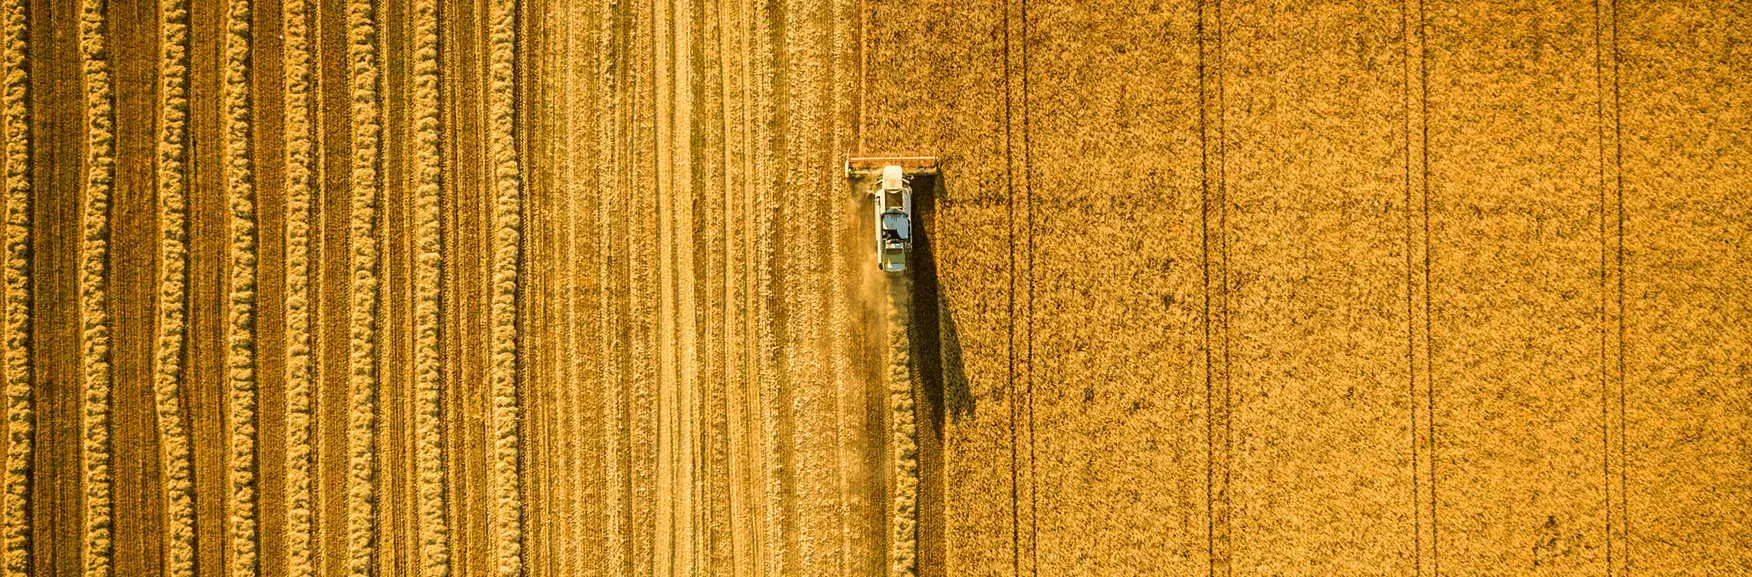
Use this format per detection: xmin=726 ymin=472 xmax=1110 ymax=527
xmin=221 ymin=0 xmax=261 ymax=577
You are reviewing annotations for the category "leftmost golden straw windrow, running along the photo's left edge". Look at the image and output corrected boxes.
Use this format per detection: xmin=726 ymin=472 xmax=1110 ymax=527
xmin=0 ymin=0 xmax=37 ymax=577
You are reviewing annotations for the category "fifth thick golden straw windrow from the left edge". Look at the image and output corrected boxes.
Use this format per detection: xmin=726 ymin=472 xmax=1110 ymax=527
xmin=278 ymin=0 xmax=315 ymax=577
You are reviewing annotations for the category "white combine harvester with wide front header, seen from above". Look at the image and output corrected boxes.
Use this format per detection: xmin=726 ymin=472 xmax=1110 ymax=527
xmin=846 ymin=156 xmax=937 ymax=272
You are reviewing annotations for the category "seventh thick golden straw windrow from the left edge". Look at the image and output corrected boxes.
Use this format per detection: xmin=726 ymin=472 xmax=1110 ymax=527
xmin=413 ymin=0 xmax=450 ymax=564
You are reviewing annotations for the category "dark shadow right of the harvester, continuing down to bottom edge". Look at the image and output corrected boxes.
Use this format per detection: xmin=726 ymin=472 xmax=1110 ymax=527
xmin=908 ymin=174 xmax=976 ymax=575
